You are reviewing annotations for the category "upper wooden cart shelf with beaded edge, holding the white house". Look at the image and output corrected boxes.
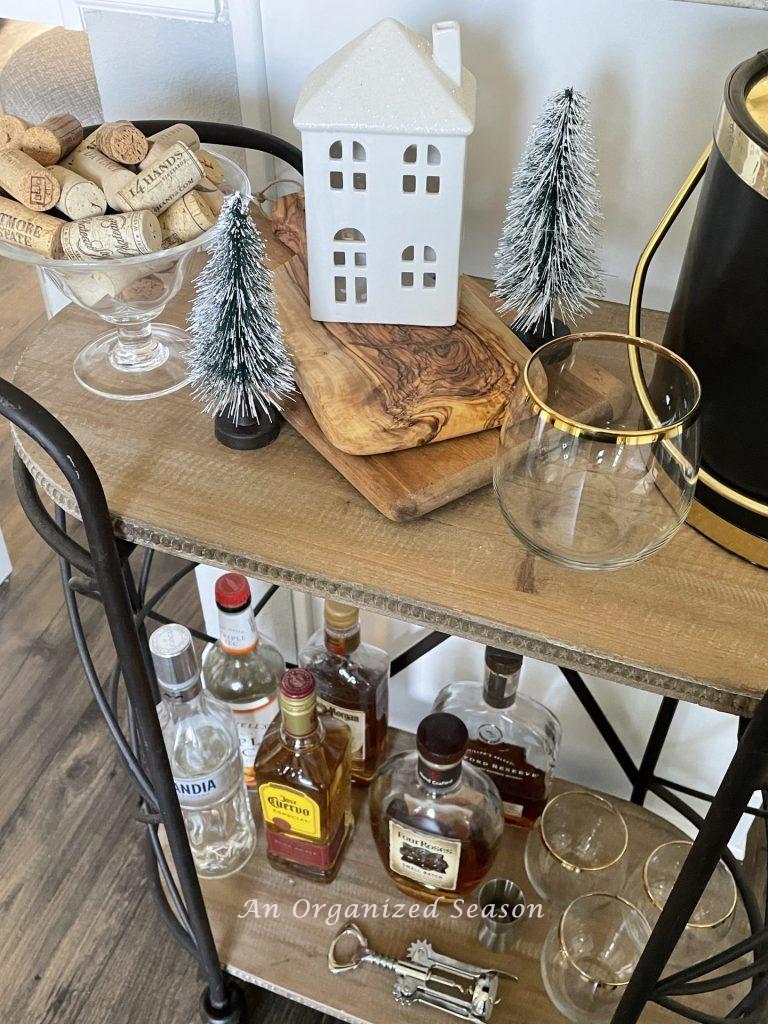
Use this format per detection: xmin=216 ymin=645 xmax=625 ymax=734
xmin=14 ymin=264 xmax=768 ymax=715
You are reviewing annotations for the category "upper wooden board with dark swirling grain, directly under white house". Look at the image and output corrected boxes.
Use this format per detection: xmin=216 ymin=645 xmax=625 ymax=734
xmin=274 ymin=255 xmax=527 ymax=456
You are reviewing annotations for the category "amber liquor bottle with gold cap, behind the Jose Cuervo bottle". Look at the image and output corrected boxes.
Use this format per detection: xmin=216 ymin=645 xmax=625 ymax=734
xmin=299 ymin=601 xmax=389 ymax=782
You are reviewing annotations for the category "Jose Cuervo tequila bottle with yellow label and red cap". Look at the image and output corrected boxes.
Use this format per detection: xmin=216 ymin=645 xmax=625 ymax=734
xmin=254 ymin=669 xmax=353 ymax=882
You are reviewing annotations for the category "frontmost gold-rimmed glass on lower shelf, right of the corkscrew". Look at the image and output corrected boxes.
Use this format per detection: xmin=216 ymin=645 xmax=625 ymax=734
xmin=541 ymin=892 xmax=650 ymax=1024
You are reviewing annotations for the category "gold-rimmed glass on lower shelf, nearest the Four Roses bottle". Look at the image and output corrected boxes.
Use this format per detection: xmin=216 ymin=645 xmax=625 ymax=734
xmin=525 ymin=790 xmax=629 ymax=906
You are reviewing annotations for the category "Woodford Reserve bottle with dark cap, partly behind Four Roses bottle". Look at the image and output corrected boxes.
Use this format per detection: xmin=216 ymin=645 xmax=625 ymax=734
xmin=432 ymin=647 xmax=561 ymax=828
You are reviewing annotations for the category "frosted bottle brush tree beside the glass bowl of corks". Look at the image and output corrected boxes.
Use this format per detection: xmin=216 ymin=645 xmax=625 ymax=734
xmin=188 ymin=193 xmax=296 ymax=449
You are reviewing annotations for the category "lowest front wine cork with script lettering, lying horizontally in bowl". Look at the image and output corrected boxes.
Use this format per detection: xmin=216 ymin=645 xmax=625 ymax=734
xmin=61 ymin=210 xmax=163 ymax=259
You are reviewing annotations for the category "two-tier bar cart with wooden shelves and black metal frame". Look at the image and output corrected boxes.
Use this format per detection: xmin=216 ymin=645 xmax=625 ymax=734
xmin=0 ymin=121 xmax=768 ymax=1024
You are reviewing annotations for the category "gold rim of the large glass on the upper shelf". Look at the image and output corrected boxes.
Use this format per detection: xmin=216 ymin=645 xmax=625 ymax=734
xmin=522 ymin=331 xmax=701 ymax=445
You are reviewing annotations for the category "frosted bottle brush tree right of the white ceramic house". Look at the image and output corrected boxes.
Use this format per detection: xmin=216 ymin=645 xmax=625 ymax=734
xmin=494 ymin=88 xmax=603 ymax=349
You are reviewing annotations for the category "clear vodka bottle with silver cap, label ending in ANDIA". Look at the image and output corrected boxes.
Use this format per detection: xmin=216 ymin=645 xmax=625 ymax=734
xmin=150 ymin=623 xmax=256 ymax=879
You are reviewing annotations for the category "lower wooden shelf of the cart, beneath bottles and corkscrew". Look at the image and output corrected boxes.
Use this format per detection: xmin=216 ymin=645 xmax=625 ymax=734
xmin=186 ymin=781 xmax=748 ymax=1024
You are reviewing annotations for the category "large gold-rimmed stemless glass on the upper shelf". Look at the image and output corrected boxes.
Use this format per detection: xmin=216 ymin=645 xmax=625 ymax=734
xmin=494 ymin=332 xmax=701 ymax=569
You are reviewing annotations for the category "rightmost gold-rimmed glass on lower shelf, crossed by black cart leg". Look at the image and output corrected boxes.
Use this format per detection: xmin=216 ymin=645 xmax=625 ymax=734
xmin=630 ymin=840 xmax=738 ymax=968
